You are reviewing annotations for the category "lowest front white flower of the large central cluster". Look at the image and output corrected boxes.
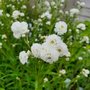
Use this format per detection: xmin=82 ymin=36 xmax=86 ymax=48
xmin=40 ymin=43 xmax=59 ymax=64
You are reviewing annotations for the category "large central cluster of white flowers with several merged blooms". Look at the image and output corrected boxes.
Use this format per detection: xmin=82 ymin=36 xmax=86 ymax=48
xmin=31 ymin=34 xmax=70 ymax=63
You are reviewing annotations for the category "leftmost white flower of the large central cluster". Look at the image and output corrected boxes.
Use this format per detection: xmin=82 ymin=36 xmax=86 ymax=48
xmin=31 ymin=43 xmax=41 ymax=58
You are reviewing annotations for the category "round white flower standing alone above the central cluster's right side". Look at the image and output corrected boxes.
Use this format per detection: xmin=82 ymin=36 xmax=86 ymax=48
xmin=54 ymin=21 xmax=67 ymax=35
